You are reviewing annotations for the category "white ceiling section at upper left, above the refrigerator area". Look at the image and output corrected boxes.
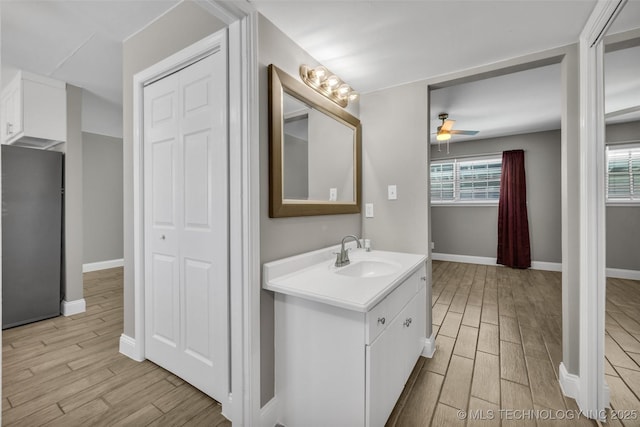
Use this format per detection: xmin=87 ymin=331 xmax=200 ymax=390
xmin=0 ymin=0 xmax=177 ymax=105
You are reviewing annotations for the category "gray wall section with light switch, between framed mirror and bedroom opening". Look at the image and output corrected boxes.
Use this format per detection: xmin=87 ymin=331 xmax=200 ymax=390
xmin=360 ymin=82 xmax=429 ymax=254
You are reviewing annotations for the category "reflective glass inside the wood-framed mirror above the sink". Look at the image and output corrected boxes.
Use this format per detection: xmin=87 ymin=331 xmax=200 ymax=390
xmin=282 ymin=92 xmax=354 ymax=202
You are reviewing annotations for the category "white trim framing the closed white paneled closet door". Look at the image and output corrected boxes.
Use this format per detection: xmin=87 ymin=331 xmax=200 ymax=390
xmin=126 ymin=0 xmax=260 ymax=426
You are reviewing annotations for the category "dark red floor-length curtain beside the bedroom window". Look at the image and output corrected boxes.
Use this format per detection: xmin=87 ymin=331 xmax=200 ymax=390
xmin=498 ymin=150 xmax=531 ymax=268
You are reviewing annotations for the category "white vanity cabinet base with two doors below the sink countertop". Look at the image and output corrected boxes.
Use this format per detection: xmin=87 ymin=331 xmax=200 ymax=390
xmin=265 ymin=251 xmax=430 ymax=427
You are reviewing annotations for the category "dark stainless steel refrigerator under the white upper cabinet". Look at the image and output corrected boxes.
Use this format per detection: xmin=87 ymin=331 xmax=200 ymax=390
xmin=2 ymin=145 xmax=63 ymax=329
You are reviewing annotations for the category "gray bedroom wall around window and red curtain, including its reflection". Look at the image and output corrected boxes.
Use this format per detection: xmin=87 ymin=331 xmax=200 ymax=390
xmin=431 ymin=122 xmax=640 ymax=271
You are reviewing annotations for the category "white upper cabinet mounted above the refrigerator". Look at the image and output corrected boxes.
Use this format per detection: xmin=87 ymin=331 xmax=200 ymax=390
xmin=0 ymin=71 xmax=67 ymax=148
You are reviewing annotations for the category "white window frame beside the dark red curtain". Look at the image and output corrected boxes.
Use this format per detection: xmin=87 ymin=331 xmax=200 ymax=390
xmin=429 ymin=153 xmax=502 ymax=207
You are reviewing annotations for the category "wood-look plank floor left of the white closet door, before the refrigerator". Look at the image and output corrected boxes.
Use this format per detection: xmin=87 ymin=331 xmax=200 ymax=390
xmin=2 ymin=268 xmax=231 ymax=427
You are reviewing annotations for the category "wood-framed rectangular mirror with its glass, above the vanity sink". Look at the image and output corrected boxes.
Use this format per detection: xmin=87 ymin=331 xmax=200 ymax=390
xmin=269 ymin=64 xmax=362 ymax=218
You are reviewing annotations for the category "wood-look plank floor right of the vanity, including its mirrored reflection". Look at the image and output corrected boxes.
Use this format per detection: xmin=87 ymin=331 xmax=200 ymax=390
xmin=387 ymin=262 xmax=640 ymax=427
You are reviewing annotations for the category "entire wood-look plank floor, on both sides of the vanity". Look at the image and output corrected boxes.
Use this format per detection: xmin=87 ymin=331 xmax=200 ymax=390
xmin=2 ymin=262 xmax=640 ymax=427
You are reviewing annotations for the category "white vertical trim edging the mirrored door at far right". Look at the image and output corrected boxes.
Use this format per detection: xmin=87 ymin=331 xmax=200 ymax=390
xmin=575 ymin=0 xmax=627 ymax=420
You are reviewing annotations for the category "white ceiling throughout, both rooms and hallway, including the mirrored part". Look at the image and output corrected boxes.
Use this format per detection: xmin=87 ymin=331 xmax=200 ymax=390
xmin=0 ymin=0 xmax=640 ymax=144
